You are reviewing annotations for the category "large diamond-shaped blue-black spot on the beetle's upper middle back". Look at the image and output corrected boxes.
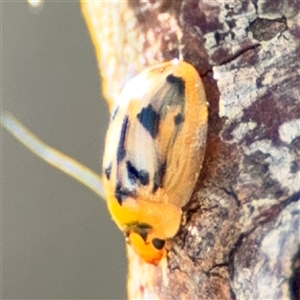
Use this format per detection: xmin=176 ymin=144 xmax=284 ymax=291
xmin=137 ymin=104 xmax=160 ymax=139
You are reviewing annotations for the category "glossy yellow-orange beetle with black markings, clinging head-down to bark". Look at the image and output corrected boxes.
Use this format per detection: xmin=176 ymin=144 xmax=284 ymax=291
xmin=102 ymin=60 xmax=208 ymax=264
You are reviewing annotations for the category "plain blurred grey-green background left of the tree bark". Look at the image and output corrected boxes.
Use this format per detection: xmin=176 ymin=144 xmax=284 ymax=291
xmin=1 ymin=1 xmax=127 ymax=299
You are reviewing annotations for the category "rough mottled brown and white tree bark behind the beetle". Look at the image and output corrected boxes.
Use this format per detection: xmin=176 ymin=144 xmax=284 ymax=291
xmin=82 ymin=0 xmax=300 ymax=299
